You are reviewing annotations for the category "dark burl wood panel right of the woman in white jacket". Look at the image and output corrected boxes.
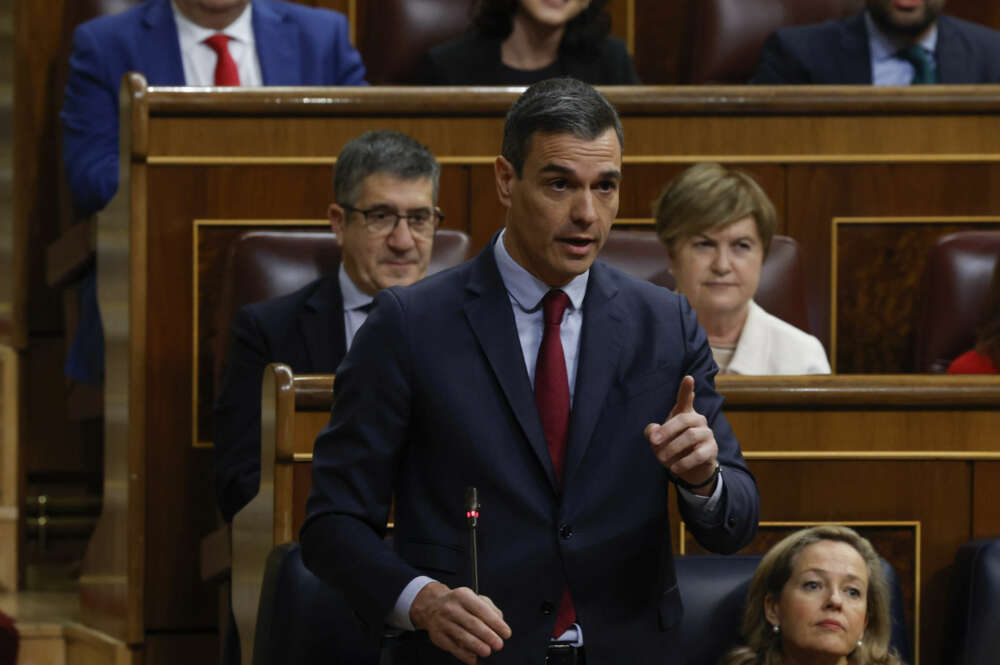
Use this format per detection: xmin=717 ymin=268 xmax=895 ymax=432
xmin=833 ymin=219 xmax=1000 ymax=373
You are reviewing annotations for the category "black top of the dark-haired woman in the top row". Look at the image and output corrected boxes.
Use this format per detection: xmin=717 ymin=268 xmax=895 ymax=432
xmin=414 ymin=31 xmax=640 ymax=85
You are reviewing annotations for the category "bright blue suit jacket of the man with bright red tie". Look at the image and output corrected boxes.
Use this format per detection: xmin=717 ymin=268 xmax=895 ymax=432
xmin=62 ymin=0 xmax=366 ymax=215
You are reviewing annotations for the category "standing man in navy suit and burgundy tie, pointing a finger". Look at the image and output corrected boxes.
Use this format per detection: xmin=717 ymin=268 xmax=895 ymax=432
xmin=301 ymin=79 xmax=759 ymax=665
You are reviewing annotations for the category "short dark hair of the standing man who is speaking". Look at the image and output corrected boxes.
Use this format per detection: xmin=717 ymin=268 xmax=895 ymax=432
xmin=500 ymin=78 xmax=625 ymax=178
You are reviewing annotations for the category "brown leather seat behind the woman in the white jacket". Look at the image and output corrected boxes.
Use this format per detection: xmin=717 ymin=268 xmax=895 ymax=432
xmin=600 ymin=230 xmax=817 ymax=335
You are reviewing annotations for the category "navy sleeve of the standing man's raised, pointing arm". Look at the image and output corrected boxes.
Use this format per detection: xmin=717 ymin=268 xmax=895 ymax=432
xmin=677 ymin=298 xmax=760 ymax=554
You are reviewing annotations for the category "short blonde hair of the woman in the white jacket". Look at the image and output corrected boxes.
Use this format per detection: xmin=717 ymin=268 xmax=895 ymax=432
xmin=653 ymin=162 xmax=778 ymax=256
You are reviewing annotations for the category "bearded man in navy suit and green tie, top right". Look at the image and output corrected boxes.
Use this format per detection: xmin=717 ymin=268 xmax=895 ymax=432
xmin=751 ymin=0 xmax=1000 ymax=85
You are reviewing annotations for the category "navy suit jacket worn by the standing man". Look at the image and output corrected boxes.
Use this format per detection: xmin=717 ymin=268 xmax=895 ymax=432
xmin=301 ymin=244 xmax=759 ymax=665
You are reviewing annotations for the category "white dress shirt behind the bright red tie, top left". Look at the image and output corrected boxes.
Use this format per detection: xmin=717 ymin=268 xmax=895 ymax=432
xmin=170 ymin=2 xmax=262 ymax=86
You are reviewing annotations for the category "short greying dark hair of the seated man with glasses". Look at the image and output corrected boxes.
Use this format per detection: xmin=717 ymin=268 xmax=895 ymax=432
xmin=333 ymin=129 xmax=441 ymax=205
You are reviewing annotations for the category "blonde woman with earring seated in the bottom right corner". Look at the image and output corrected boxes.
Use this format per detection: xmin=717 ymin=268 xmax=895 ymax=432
xmin=722 ymin=525 xmax=901 ymax=665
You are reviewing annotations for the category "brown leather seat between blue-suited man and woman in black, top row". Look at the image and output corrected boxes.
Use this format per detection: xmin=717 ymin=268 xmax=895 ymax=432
xmin=359 ymin=0 xmax=476 ymax=85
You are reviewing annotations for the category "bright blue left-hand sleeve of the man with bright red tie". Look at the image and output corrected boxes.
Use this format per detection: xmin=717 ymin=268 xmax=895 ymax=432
xmin=61 ymin=25 xmax=119 ymax=215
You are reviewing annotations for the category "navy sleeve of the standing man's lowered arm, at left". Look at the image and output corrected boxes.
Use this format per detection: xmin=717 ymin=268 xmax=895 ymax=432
xmin=300 ymin=290 xmax=420 ymax=632
